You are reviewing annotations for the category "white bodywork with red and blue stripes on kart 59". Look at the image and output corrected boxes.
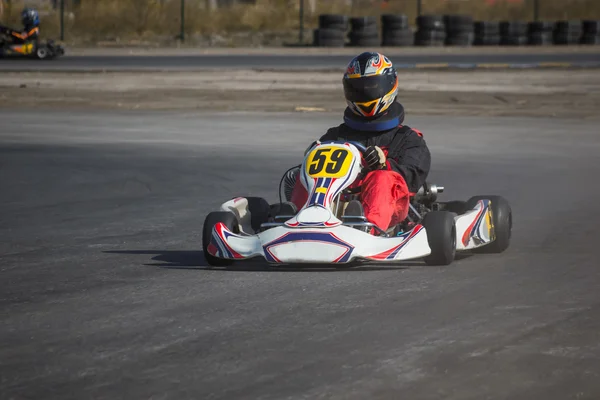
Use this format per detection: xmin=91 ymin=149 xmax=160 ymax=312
xmin=208 ymin=143 xmax=494 ymax=264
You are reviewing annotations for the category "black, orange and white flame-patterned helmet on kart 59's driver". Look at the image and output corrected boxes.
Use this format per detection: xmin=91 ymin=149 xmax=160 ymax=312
xmin=343 ymin=52 xmax=398 ymax=119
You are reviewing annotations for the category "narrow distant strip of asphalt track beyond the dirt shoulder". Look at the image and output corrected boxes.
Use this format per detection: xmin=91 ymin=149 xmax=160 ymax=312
xmin=0 ymin=53 xmax=600 ymax=71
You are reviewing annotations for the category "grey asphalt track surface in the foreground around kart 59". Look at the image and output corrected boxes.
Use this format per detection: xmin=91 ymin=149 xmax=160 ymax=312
xmin=0 ymin=111 xmax=600 ymax=400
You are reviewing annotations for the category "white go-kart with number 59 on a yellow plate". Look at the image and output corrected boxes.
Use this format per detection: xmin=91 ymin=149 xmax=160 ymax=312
xmin=202 ymin=141 xmax=512 ymax=266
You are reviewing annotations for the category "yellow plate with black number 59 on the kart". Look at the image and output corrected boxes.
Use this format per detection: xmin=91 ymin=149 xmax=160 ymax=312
xmin=306 ymin=146 xmax=352 ymax=178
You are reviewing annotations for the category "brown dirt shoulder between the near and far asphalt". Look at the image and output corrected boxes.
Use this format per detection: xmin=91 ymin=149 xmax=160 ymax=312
xmin=0 ymin=70 xmax=600 ymax=119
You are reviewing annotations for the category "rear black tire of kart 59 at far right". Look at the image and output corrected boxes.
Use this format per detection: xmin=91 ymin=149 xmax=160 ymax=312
xmin=467 ymin=195 xmax=512 ymax=254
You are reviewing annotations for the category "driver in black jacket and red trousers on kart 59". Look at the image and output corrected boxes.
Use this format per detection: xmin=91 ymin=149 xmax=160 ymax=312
xmin=290 ymin=52 xmax=431 ymax=236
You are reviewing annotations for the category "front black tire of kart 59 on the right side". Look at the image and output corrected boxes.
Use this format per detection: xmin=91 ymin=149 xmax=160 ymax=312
xmin=422 ymin=211 xmax=456 ymax=265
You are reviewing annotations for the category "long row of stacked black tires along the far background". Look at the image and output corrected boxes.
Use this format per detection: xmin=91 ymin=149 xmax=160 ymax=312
xmin=313 ymin=14 xmax=600 ymax=47
